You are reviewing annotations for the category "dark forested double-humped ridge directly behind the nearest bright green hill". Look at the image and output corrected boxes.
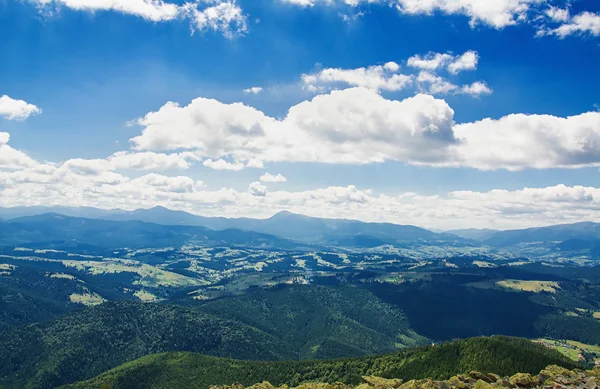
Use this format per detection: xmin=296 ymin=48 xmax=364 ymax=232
xmin=0 ymin=286 xmax=427 ymax=388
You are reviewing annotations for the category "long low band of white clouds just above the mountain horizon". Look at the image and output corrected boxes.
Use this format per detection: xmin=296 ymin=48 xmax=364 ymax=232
xmin=0 ymin=152 xmax=600 ymax=228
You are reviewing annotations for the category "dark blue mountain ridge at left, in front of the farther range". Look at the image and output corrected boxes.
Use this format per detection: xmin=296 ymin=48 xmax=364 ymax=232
xmin=0 ymin=213 xmax=310 ymax=249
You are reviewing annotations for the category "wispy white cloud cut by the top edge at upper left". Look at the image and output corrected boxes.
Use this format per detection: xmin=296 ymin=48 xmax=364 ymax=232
xmin=28 ymin=0 xmax=247 ymax=37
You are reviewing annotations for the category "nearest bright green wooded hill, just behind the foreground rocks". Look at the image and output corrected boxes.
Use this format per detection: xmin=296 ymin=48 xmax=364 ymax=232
xmin=65 ymin=337 xmax=577 ymax=389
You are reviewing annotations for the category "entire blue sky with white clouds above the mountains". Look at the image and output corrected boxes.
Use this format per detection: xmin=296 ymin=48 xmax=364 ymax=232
xmin=0 ymin=0 xmax=600 ymax=229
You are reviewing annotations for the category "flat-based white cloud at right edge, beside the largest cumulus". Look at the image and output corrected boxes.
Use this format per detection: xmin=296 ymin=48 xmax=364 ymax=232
xmin=449 ymin=112 xmax=600 ymax=170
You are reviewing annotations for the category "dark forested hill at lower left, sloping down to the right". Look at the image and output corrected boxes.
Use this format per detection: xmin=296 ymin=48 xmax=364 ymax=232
xmin=0 ymin=302 xmax=296 ymax=388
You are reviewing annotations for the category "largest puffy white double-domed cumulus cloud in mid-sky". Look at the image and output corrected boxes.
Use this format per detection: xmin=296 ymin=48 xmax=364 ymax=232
xmin=131 ymin=88 xmax=454 ymax=163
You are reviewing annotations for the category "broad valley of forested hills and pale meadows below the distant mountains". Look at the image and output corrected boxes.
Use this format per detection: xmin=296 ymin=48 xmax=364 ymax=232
xmin=0 ymin=209 xmax=600 ymax=389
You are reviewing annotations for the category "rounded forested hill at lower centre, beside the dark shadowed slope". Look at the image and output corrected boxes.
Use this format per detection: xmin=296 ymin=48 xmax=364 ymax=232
xmin=200 ymin=285 xmax=428 ymax=359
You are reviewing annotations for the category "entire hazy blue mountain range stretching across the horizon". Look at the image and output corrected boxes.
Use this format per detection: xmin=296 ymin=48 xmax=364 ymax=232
xmin=0 ymin=207 xmax=600 ymax=250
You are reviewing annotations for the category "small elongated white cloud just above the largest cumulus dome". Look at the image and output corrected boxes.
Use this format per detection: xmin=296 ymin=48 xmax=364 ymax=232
xmin=302 ymin=62 xmax=413 ymax=92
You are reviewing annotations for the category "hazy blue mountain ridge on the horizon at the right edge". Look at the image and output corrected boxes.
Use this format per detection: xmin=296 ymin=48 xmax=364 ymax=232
xmin=484 ymin=222 xmax=600 ymax=247
